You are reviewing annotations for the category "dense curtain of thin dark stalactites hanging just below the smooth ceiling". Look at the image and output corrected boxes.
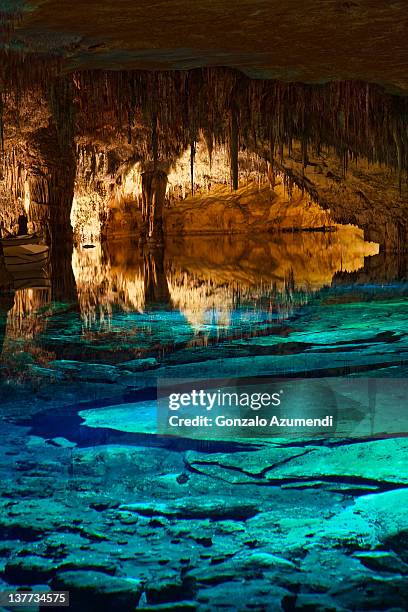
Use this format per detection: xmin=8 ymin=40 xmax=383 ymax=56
xmin=67 ymin=69 xmax=407 ymax=179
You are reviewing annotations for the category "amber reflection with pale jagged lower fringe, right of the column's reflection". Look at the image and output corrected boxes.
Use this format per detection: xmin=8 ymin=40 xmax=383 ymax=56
xmin=166 ymin=228 xmax=378 ymax=329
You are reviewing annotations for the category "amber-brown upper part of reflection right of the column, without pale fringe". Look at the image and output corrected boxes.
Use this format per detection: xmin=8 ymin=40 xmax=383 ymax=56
xmin=166 ymin=227 xmax=378 ymax=290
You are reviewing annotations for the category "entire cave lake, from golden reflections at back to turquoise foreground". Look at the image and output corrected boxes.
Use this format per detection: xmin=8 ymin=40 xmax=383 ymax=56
xmin=0 ymin=236 xmax=408 ymax=610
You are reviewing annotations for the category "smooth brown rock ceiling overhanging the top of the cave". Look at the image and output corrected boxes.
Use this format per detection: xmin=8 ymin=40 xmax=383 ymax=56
xmin=0 ymin=0 xmax=408 ymax=93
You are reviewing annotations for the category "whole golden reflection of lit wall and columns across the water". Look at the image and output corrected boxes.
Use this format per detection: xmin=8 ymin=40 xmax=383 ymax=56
xmin=2 ymin=227 xmax=378 ymax=338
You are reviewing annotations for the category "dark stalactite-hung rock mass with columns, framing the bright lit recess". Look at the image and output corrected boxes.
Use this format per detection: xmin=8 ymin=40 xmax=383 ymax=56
xmin=2 ymin=65 xmax=408 ymax=250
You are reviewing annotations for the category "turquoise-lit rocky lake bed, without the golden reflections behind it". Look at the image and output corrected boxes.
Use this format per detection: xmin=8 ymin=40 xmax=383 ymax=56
xmin=0 ymin=289 xmax=408 ymax=611
